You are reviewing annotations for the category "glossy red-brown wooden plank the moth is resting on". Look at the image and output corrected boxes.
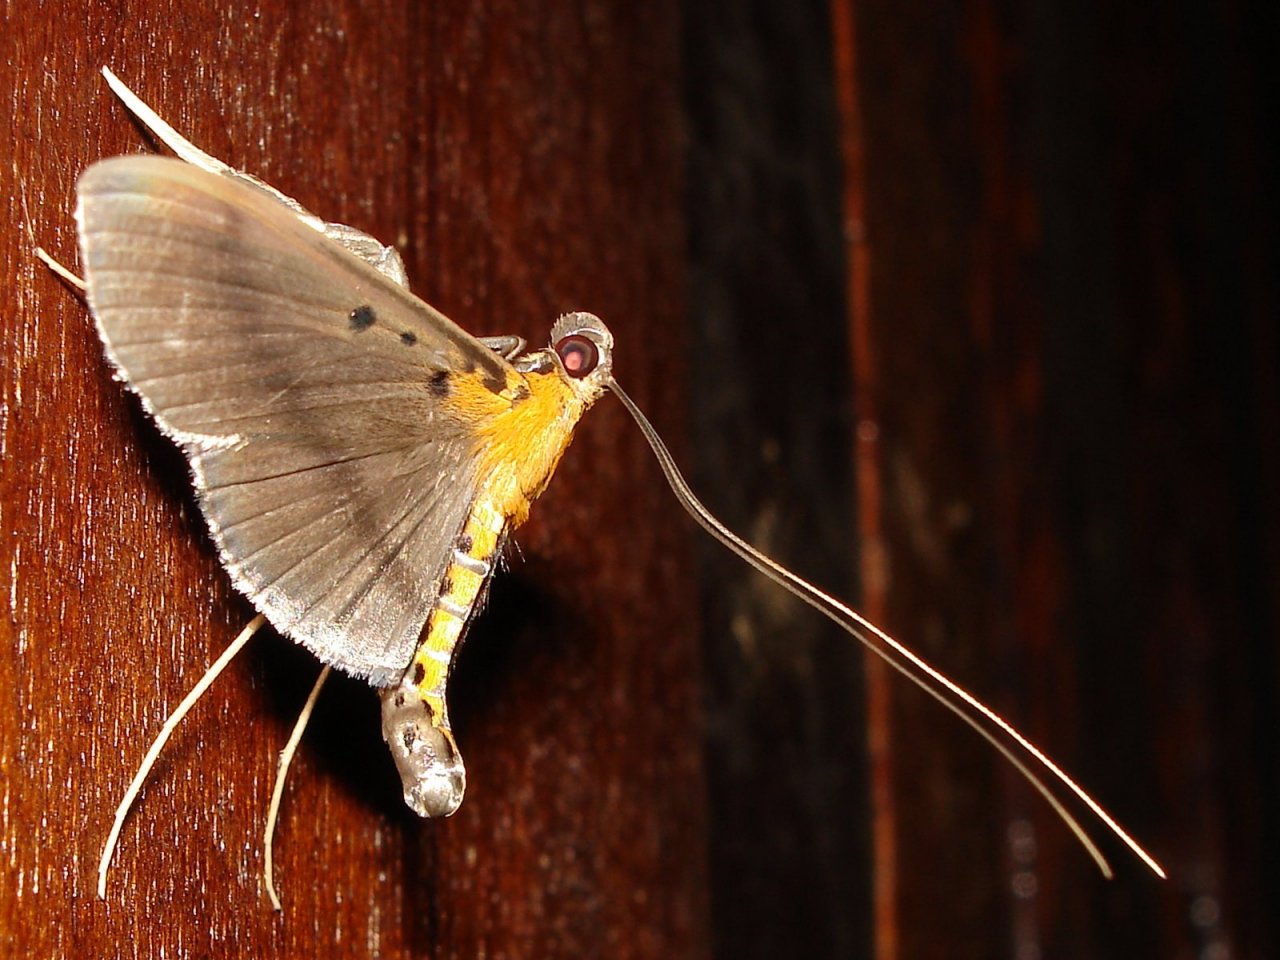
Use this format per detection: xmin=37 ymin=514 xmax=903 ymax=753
xmin=0 ymin=3 xmax=708 ymax=957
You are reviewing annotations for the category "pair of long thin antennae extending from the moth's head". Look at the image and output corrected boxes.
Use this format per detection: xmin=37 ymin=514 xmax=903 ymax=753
xmin=608 ymin=378 xmax=1166 ymax=879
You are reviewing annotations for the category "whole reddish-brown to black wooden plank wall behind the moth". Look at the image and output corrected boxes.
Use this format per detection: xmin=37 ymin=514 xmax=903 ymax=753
xmin=0 ymin=0 xmax=1280 ymax=960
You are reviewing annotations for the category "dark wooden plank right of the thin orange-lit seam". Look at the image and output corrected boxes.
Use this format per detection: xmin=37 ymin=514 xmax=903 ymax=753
xmin=833 ymin=0 xmax=1280 ymax=960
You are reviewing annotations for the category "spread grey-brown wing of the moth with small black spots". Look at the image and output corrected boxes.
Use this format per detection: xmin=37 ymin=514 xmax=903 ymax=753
xmin=77 ymin=156 xmax=518 ymax=685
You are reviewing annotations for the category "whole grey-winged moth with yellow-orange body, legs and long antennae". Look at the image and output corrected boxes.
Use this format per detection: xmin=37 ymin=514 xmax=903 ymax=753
xmin=37 ymin=69 xmax=1164 ymax=909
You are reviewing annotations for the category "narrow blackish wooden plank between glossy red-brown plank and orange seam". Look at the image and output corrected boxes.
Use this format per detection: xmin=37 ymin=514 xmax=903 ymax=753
xmin=685 ymin=3 xmax=870 ymax=960
